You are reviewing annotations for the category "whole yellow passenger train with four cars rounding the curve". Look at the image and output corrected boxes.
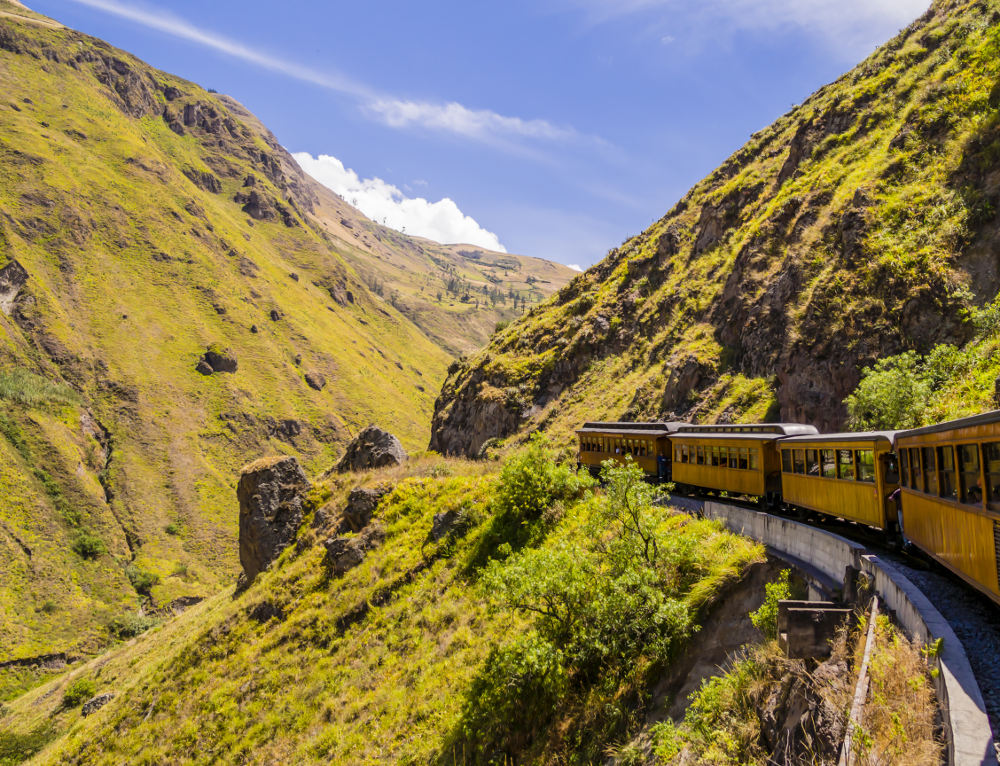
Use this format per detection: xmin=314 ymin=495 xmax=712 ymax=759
xmin=576 ymin=410 xmax=1000 ymax=606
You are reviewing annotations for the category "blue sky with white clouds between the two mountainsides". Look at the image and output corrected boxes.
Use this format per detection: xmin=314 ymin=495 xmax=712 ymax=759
xmin=26 ymin=0 xmax=929 ymax=268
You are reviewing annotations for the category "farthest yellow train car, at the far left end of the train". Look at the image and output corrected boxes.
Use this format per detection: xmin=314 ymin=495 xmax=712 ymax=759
xmin=576 ymin=422 xmax=686 ymax=481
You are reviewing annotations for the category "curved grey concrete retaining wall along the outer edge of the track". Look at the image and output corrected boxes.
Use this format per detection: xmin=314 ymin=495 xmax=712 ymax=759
xmin=700 ymin=498 xmax=997 ymax=766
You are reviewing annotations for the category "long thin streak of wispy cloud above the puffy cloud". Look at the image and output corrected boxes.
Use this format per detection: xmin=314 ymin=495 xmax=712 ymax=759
xmin=66 ymin=0 xmax=592 ymax=153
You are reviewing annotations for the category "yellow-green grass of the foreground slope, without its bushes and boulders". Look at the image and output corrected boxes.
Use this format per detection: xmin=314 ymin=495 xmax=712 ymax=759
xmin=2 ymin=458 xmax=761 ymax=764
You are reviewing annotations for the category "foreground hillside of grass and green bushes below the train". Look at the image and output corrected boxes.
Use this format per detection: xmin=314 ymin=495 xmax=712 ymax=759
xmin=3 ymin=442 xmax=763 ymax=764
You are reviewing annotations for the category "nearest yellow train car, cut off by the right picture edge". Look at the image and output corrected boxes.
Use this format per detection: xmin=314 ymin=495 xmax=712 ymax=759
xmin=896 ymin=411 xmax=1000 ymax=603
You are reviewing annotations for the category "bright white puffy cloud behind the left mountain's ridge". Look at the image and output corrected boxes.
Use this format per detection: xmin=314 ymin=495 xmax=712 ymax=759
xmin=292 ymin=152 xmax=507 ymax=253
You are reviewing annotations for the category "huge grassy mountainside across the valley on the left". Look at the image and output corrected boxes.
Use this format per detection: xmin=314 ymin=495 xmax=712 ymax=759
xmin=0 ymin=0 xmax=571 ymax=684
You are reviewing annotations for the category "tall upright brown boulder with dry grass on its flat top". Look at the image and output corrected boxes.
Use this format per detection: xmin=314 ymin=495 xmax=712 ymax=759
xmin=236 ymin=456 xmax=309 ymax=583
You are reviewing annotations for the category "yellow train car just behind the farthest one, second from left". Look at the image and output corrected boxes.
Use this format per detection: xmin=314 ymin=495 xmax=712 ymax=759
xmin=670 ymin=423 xmax=816 ymax=500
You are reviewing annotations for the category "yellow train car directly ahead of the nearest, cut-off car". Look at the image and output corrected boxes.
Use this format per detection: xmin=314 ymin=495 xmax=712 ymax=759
xmin=780 ymin=431 xmax=899 ymax=530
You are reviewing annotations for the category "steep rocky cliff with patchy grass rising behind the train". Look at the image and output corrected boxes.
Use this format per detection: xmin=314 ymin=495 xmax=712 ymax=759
xmin=430 ymin=2 xmax=1000 ymax=455
